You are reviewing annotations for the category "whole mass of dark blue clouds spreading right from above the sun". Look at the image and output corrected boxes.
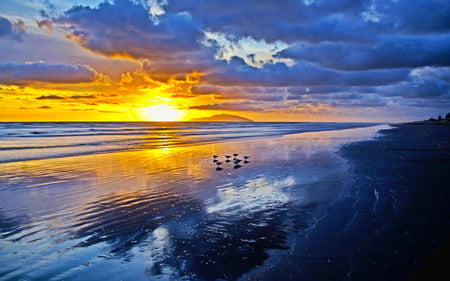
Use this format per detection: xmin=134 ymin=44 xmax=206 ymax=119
xmin=38 ymin=0 xmax=450 ymax=110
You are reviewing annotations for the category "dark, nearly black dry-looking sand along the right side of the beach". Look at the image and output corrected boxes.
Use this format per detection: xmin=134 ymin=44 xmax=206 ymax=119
xmin=241 ymin=124 xmax=450 ymax=281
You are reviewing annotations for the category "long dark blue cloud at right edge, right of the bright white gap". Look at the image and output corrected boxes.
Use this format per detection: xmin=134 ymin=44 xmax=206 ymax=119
xmin=281 ymin=34 xmax=450 ymax=70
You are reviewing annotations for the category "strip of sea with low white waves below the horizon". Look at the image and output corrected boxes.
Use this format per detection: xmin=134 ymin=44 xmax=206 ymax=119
xmin=0 ymin=122 xmax=375 ymax=163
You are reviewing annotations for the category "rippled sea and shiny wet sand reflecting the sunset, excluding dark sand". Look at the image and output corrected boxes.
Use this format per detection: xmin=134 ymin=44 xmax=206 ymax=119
xmin=0 ymin=123 xmax=389 ymax=280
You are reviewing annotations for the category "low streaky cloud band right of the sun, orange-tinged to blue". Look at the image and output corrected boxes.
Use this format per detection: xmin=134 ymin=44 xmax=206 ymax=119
xmin=192 ymin=67 xmax=450 ymax=112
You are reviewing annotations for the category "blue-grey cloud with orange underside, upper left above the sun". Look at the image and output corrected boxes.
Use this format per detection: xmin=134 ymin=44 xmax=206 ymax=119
xmin=41 ymin=0 xmax=217 ymax=82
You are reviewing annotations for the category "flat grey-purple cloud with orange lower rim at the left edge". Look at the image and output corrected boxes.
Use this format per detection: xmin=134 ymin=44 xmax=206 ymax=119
xmin=0 ymin=62 xmax=97 ymax=85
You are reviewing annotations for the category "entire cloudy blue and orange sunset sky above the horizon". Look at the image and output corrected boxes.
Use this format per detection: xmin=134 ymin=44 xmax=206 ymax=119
xmin=0 ymin=0 xmax=450 ymax=122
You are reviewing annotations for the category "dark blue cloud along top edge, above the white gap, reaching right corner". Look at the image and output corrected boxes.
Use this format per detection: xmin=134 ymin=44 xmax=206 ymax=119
xmin=167 ymin=0 xmax=450 ymax=42
